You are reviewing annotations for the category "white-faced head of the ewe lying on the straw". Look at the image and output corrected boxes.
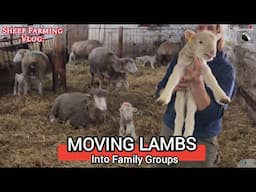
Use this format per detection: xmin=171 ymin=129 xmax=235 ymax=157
xmin=90 ymin=88 xmax=107 ymax=111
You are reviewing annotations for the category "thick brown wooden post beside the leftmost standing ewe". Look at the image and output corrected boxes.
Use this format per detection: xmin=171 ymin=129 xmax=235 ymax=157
xmin=51 ymin=34 xmax=67 ymax=91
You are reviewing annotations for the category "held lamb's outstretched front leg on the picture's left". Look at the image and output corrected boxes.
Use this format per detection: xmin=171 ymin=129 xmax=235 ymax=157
xmin=156 ymin=63 xmax=184 ymax=105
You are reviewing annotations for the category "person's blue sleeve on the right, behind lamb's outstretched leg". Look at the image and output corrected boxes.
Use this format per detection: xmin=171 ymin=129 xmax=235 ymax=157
xmin=197 ymin=63 xmax=236 ymax=124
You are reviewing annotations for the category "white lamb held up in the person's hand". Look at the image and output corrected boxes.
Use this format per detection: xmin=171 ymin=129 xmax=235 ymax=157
xmin=156 ymin=30 xmax=231 ymax=137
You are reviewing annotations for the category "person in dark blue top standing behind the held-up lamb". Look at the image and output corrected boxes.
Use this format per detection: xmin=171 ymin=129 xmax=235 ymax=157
xmin=156 ymin=24 xmax=236 ymax=167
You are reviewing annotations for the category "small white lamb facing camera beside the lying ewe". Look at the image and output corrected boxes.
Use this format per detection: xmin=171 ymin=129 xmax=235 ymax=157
xmin=119 ymin=102 xmax=138 ymax=140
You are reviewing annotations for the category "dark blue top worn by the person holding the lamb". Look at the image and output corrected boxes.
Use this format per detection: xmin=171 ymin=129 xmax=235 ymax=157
xmin=156 ymin=52 xmax=236 ymax=138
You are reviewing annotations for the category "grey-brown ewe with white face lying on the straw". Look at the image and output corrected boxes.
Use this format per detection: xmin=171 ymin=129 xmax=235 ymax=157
xmin=49 ymin=88 xmax=107 ymax=128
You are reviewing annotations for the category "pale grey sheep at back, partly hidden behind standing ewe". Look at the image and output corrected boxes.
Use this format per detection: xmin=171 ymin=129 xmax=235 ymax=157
xmin=68 ymin=40 xmax=103 ymax=64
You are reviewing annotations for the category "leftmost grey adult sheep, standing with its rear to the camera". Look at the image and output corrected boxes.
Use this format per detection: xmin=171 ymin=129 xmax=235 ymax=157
xmin=13 ymin=49 xmax=50 ymax=95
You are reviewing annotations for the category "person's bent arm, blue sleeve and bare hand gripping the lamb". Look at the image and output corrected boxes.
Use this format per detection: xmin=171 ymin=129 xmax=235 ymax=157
xmin=178 ymin=58 xmax=235 ymax=123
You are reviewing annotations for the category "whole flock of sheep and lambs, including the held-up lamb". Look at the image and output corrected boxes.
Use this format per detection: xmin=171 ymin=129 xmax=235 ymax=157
xmin=9 ymin=30 xmax=226 ymax=139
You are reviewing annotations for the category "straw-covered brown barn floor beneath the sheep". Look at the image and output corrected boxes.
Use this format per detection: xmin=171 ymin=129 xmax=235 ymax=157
xmin=0 ymin=65 xmax=256 ymax=167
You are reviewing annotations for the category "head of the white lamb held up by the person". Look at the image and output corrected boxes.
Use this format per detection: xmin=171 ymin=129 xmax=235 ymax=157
xmin=185 ymin=30 xmax=221 ymax=61
